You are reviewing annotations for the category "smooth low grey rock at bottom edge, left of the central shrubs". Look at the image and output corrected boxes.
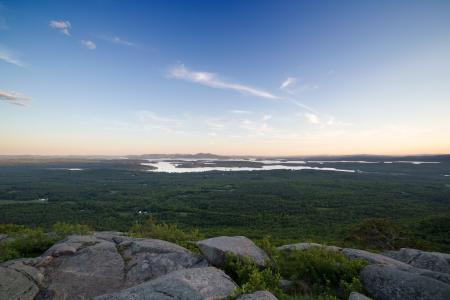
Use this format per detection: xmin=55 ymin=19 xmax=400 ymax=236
xmin=94 ymin=267 xmax=237 ymax=300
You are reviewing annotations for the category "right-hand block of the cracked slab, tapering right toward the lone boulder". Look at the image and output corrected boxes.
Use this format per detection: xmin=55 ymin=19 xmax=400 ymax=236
xmin=118 ymin=239 xmax=208 ymax=286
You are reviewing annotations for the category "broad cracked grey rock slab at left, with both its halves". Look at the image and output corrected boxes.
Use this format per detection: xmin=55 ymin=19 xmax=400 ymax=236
xmin=35 ymin=232 xmax=208 ymax=300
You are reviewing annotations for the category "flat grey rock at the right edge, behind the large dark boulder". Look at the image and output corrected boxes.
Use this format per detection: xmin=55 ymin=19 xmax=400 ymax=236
xmin=383 ymin=248 xmax=450 ymax=274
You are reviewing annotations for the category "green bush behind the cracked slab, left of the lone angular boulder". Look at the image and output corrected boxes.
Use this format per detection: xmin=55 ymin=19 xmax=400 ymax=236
xmin=129 ymin=218 xmax=204 ymax=252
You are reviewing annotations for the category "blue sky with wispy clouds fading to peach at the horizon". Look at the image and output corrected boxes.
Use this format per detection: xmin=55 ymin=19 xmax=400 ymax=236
xmin=0 ymin=0 xmax=450 ymax=155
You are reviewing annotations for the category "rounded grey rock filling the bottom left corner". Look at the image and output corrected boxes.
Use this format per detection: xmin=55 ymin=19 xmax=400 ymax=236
xmin=0 ymin=267 xmax=39 ymax=300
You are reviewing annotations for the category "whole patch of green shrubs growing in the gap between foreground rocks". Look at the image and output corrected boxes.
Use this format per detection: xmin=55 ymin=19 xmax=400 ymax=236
xmin=225 ymin=237 xmax=366 ymax=300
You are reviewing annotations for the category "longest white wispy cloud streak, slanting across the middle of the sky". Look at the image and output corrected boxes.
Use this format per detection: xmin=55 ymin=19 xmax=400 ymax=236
xmin=169 ymin=64 xmax=278 ymax=99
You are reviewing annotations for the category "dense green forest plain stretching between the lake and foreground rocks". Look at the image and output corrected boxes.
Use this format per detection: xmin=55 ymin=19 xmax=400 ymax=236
xmin=0 ymin=161 xmax=450 ymax=251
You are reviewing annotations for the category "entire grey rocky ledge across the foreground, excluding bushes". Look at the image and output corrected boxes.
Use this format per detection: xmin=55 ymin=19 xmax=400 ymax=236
xmin=0 ymin=232 xmax=450 ymax=300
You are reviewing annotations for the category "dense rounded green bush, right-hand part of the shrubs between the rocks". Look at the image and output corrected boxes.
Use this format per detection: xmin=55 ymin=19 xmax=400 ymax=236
xmin=275 ymin=247 xmax=367 ymax=298
